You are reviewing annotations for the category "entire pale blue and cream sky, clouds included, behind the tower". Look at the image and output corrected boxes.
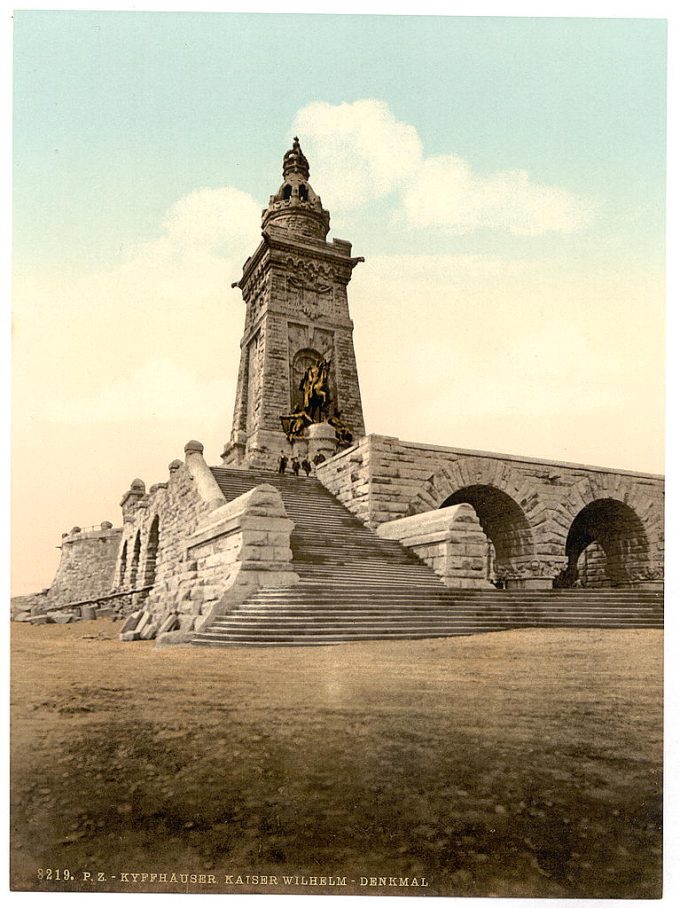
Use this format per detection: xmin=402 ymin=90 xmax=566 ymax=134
xmin=13 ymin=11 xmax=666 ymax=593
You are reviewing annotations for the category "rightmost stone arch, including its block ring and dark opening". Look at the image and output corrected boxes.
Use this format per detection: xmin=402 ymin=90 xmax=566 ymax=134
xmin=554 ymin=472 xmax=663 ymax=586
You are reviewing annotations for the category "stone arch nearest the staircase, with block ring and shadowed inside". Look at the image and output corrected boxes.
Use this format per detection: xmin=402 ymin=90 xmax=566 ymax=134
xmin=409 ymin=456 xmax=561 ymax=586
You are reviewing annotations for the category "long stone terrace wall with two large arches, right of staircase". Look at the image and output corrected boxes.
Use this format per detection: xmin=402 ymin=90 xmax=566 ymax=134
xmin=318 ymin=435 xmax=664 ymax=588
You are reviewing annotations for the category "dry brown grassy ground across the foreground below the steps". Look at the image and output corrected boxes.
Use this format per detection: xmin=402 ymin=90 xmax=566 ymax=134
xmin=7 ymin=620 xmax=662 ymax=898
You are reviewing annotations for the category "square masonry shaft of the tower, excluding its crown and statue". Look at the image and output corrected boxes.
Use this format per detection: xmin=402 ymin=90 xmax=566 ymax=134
xmin=222 ymin=227 xmax=364 ymax=468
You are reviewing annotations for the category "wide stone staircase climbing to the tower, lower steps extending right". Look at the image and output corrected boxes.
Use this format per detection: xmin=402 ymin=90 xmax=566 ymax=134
xmin=193 ymin=467 xmax=663 ymax=646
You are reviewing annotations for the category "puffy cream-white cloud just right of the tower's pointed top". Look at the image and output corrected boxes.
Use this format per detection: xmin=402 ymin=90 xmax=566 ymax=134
xmin=293 ymin=99 xmax=594 ymax=236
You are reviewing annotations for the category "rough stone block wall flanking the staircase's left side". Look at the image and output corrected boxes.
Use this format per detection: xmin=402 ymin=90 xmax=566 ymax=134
xmin=115 ymin=442 xmax=299 ymax=639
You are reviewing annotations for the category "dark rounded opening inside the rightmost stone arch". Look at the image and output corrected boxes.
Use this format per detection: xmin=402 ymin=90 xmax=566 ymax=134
xmin=560 ymin=498 xmax=649 ymax=587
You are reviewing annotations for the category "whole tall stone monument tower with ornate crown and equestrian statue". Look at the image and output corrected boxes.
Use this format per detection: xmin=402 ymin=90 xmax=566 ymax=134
xmin=222 ymin=137 xmax=365 ymax=476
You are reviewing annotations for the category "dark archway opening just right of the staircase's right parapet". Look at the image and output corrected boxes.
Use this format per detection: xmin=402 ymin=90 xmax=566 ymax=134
xmin=440 ymin=484 xmax=535 ymax=586
